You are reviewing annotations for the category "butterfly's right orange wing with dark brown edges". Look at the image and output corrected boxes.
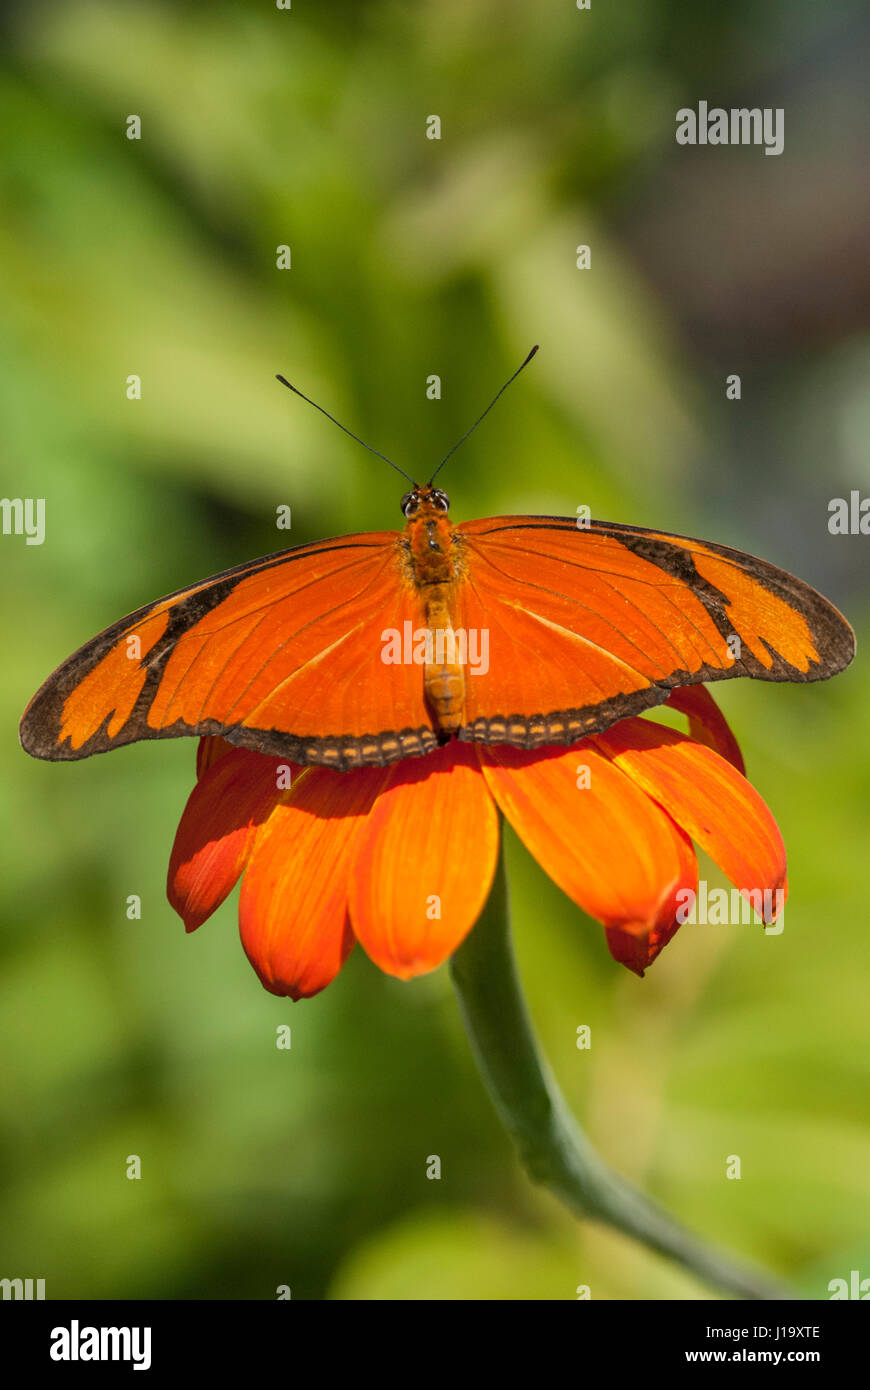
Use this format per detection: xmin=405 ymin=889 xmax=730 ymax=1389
xmin=457 ymin=517 xmax=855 ymax=748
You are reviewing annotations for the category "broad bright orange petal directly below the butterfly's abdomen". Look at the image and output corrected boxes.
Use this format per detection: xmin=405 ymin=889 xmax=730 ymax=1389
xmin=349 ymin=741 xmax=499 ymax=980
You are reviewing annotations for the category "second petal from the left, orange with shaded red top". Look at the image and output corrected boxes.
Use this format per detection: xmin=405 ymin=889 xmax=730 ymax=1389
xmin=239 ymin=765 xmax=389 ymax=999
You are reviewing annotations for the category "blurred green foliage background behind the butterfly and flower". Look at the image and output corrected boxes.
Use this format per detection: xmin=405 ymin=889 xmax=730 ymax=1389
xmin=0 ymin=0 xmax=870 ymax=1300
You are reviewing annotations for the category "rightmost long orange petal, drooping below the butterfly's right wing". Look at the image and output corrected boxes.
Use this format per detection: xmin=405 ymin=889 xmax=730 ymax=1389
xmin=591 ymin=719 xmax=785 ymax=922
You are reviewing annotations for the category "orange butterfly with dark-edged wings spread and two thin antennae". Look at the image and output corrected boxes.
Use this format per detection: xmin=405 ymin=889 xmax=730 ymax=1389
xmin=21 ymin=349 xmax=855 ymax=771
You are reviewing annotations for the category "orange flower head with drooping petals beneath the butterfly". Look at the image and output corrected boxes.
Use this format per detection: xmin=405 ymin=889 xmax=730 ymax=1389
xmin=168 ymin=685 xmax=785 ymax=999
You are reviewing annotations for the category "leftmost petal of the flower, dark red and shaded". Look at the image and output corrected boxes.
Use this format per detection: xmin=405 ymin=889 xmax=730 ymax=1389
xmin=167 ymin=739 xmax=282 ymax=931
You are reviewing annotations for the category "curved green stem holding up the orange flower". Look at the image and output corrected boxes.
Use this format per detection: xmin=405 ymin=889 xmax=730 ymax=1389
xmin=450 ymin=837 xmax=796 ymax=1298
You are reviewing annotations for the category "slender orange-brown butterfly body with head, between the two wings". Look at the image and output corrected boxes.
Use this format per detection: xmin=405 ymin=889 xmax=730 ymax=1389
xmin=403 ymin=487 xmax=466 ymax=734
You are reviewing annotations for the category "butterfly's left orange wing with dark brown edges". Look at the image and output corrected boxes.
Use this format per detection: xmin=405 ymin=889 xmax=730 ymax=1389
xmin=21 ymin=531 xmax=438 ymax=769
